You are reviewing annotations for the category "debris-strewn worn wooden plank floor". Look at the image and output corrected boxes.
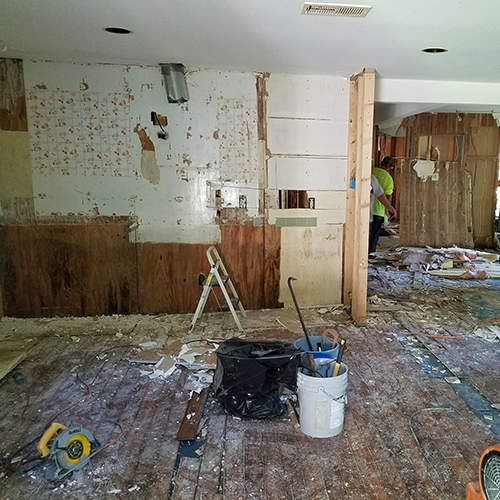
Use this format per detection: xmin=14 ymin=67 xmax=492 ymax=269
xmin=0 ymin=275 xmax=500 ymax=500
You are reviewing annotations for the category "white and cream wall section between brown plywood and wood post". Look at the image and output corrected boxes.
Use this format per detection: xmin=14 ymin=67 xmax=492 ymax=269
xmin=267 ymin=75 xmax=349 ymax=307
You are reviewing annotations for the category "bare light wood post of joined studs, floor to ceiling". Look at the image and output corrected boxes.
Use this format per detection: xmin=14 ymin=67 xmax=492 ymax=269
xmin=343 ymin=69 xmax=375 ymax=325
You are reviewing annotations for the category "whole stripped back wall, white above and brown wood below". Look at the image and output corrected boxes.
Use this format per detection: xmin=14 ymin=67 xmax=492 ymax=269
xmin=0 ymin=61 xmax=348 ymax=316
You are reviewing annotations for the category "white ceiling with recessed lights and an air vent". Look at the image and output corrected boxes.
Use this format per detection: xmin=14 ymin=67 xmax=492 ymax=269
xmin=0 ymin=0 xmax=500 ymax=122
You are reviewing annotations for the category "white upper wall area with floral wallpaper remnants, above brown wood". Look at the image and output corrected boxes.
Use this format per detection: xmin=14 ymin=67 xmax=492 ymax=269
xmin=21 ymin=61 xmax=259 ymax=243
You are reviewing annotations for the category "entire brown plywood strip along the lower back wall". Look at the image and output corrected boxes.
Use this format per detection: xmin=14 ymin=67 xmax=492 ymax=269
xmin=0 ymin=223 xmax=281 ymax=317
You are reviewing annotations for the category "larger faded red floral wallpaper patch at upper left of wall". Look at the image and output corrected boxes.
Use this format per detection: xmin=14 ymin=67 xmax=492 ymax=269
xmin=27 ymin=89 xmax=135 ymax=177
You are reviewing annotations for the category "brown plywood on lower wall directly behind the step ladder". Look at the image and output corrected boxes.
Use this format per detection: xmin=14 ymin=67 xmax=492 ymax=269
xmin=138 ymin=225 xmax=280 ymax=314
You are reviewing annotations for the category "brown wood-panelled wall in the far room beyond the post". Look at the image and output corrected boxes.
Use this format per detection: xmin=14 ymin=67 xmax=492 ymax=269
xmin=400 ymin=113 xmax=499 ymax=247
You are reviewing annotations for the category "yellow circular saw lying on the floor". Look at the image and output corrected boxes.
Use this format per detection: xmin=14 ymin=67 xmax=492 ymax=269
xmin=37 ymin=422 xmax=102 ymax=479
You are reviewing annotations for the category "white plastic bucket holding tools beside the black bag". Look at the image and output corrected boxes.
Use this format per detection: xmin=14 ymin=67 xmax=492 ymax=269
xmin=297 ymin=363 xmax=348 ymax=437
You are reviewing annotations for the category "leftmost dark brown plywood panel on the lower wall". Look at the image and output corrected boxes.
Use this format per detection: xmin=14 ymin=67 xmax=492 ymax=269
xmin=0 ymin=223 xmax=138 ymax=317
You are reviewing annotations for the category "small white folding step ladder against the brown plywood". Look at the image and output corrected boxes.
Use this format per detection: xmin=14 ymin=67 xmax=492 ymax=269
xmin=188 ymin=246 xmax=247 ymax=334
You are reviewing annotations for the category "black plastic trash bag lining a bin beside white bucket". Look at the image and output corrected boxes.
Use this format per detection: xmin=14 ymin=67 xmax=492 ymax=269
xmin=214 ymin=338 xmax=307 ymax=419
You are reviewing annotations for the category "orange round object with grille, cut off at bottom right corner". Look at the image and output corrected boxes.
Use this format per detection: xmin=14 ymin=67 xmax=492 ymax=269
xmin=467 ymin=445 xmax=500 ymax=500
